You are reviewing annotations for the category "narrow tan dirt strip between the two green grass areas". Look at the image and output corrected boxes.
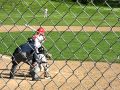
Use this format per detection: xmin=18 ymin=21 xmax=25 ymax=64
xmin=0 ymin=25 xmax=120 ymax=32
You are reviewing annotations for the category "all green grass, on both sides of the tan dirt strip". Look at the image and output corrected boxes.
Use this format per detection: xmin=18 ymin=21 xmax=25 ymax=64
xmin=0 ymin=0 xmax=120 ymax=62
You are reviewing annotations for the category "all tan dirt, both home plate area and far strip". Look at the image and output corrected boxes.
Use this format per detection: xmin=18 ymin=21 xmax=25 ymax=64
xmin=0 ymin=25 xmax=120 ymax=90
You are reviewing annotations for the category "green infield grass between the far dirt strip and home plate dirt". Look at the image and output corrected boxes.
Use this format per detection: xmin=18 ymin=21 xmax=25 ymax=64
xmin=0 ymin=32 xmax=120 ymax=62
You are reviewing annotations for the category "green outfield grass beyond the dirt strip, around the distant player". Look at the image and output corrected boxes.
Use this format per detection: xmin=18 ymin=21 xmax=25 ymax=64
xmin=0 ymin=0 xmax=120 ymax=26
